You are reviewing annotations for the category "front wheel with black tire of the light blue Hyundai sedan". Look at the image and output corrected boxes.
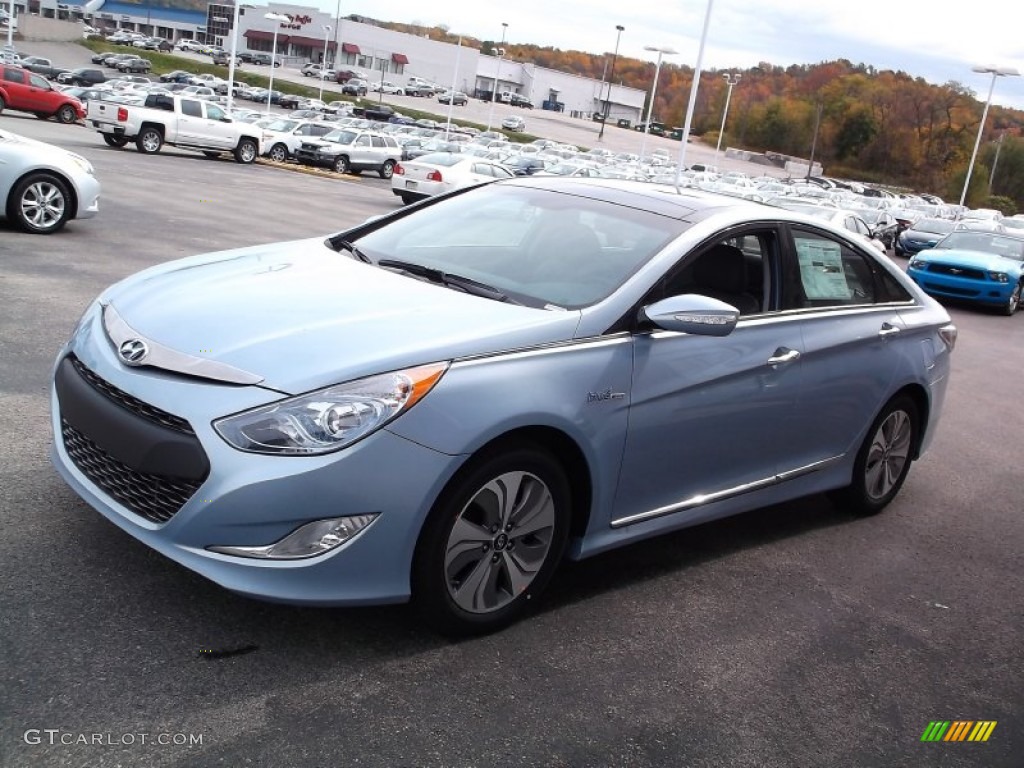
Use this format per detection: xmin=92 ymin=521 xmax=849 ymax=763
xmin=413 ymin=443 xmax=571 ymax=636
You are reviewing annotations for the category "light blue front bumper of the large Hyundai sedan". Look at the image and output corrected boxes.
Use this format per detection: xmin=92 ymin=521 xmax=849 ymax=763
xmin=50 ymin=303 xmax=461 ymax=605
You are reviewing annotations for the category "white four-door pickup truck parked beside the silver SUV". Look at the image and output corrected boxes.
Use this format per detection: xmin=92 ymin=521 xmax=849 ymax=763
xmin=85 ymin=93 xmax=260 ymax=164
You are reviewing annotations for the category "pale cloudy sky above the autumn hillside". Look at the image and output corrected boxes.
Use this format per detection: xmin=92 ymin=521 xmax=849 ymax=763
xmin=286 ymin=0 xmax=1024 ymax=109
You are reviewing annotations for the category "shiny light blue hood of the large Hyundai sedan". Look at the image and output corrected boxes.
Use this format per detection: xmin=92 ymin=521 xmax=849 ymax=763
xmin=100 ymin=240 xmax=580 ymax=394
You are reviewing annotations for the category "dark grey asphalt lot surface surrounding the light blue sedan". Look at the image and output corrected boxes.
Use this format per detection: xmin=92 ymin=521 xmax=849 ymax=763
xmin=0 ymin=114 xmax=1024 ymax=768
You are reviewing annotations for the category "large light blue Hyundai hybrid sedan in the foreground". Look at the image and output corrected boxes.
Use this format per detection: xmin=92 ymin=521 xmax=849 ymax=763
xmin=52 ymin=176 xmax=956 ymax=634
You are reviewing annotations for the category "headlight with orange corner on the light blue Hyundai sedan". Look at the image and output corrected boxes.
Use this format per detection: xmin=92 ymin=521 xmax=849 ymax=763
xmin=213 ymin=362 xmax=447 ymax=456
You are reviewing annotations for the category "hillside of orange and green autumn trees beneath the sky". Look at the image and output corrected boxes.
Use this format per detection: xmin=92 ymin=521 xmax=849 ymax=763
xmin=358 ymin=17 xmax=1024 ymax=210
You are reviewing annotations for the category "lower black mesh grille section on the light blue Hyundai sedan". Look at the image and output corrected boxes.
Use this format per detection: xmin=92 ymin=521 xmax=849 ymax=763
xmin=60 ymin=419 xmax=203 ymax=523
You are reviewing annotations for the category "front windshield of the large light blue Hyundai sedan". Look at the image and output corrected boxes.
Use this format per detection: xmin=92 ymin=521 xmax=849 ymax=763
xmin=357 ymin=183 xmax=688 ymax=309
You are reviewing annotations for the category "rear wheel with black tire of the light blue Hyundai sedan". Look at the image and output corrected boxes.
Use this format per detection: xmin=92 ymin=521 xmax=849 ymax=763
xmin=829 ymin=395 xmax=921 ymax=516
